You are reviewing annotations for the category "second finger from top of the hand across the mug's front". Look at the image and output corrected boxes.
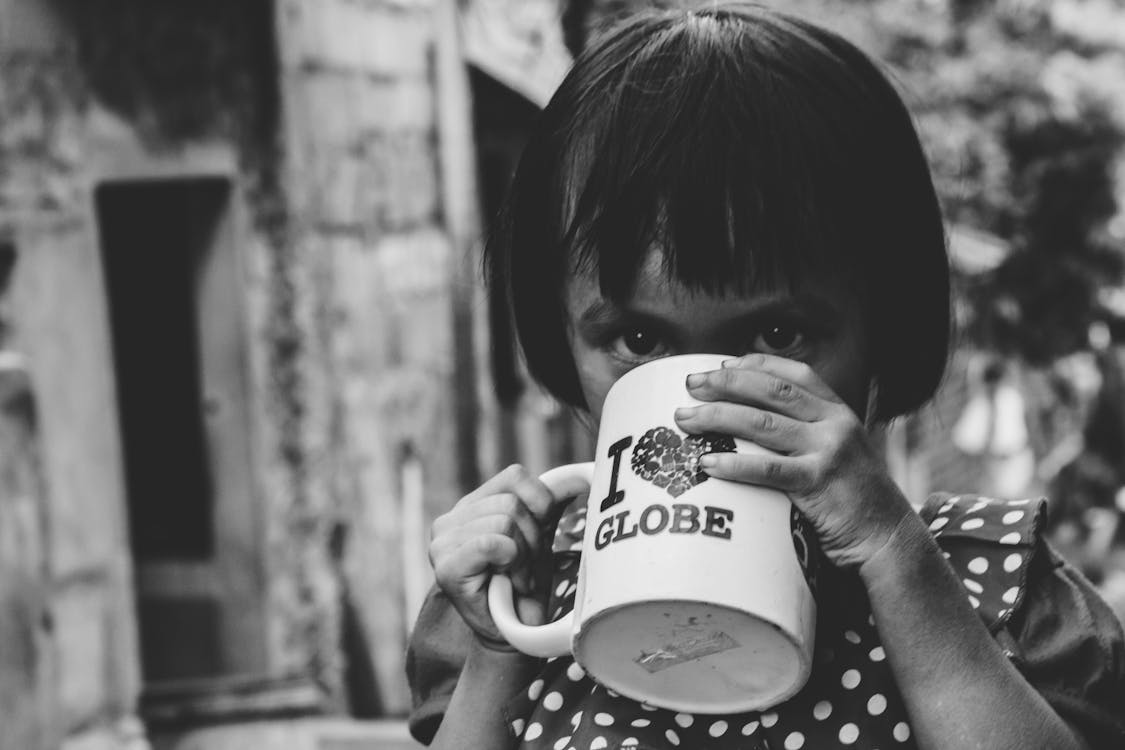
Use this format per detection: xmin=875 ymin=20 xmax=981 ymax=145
xmin=687 ymin=368 xmax=827 ymax=422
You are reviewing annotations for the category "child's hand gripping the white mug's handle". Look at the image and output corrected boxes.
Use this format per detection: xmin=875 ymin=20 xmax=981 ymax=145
xmin=430 ymin=464 xmax=565 ymax=650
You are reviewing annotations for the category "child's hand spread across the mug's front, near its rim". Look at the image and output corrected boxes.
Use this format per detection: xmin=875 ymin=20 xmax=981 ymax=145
xmin=676 ymin=354 xmax=915 ymax=567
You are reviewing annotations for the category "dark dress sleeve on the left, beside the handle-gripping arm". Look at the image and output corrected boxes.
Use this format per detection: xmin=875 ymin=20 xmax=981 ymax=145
xmin=406 ymin=586 xmax=473 ymax=744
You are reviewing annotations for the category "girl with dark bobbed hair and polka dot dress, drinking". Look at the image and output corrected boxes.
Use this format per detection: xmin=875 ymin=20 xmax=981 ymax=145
xmin=408 ymin=3 xmax=1125 ymax=750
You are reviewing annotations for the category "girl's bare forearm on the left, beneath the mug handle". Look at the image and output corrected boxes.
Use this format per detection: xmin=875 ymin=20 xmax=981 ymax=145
xmin=430 ymin=639 xmax=539 ymax=750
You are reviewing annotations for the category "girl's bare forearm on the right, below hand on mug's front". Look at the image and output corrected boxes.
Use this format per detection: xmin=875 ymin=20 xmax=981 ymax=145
xmin=860 ymin=499 xmax=1087 ymax=750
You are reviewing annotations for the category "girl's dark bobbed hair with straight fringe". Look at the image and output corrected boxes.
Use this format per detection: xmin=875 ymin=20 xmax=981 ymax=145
xmin=485 ymin=2 xmax=950 ymax=421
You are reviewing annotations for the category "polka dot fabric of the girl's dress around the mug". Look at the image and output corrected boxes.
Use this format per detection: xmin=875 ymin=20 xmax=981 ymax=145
xmin=505 ymin=496 xmax=1043 ymax=750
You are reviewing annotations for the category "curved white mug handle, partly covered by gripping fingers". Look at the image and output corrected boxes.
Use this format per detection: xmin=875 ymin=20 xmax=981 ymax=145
xmin=488 ymin=462 xmax=594 ymax=658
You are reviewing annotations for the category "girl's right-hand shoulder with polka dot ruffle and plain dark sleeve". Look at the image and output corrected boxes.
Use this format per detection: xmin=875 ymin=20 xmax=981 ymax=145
xmin=921 ymin=495 xmax=1125 ymax=747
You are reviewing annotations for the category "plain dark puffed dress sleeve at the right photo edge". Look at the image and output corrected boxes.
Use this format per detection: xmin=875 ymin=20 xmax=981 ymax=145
xmin=1002 ymin=540 xmax=1125 ymax=749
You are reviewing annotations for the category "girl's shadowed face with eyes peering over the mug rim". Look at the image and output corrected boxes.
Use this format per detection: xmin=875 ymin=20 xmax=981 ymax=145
xmin=566 ymin=250 xmax=871 ymax=419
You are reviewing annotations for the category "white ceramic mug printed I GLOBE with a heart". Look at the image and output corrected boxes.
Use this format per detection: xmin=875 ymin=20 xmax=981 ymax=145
xmin=488 ymin=354 xmax=817 ymax=714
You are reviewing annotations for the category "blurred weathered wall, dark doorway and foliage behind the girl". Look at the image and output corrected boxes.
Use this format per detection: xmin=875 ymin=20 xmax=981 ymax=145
xmin=0 ymin=0 xmax=1125 ymax=750
